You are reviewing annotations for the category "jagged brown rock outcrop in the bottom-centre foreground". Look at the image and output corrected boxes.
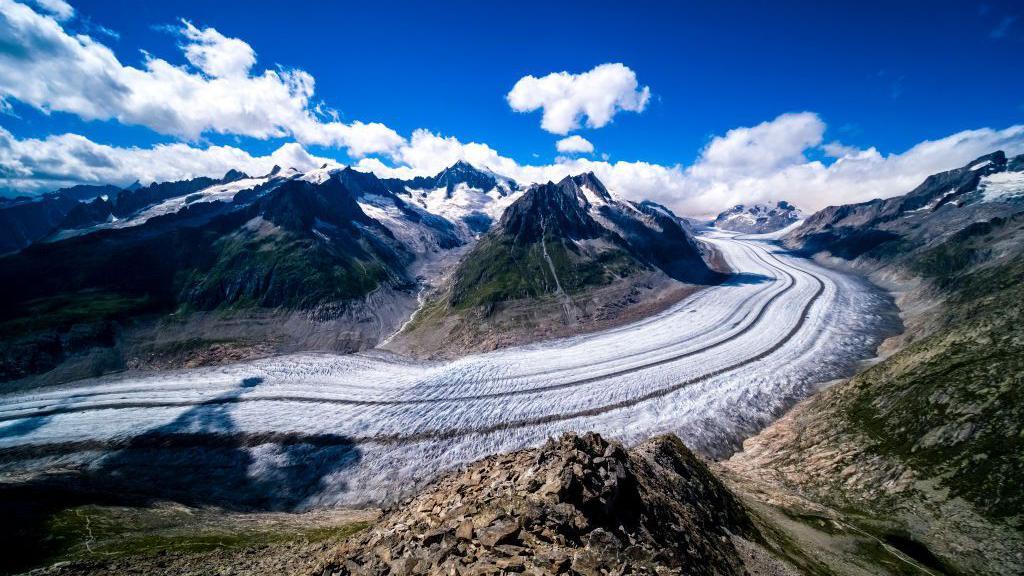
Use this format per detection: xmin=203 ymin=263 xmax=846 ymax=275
xmin=315 ymin=434 xmax=762 ymax=576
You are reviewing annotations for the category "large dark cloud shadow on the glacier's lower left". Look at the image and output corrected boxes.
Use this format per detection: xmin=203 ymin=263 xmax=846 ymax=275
xmin=88 ymin=378 xmax=360 ymax=510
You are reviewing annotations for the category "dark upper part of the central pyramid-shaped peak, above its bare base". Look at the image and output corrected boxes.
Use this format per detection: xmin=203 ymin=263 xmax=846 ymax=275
xmin=451 ymin=173 xmax=712 ymax=307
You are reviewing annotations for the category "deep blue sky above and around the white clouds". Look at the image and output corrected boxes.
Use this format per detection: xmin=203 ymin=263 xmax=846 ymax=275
xmin=0 ymin=0 xmax=1024 ymax=214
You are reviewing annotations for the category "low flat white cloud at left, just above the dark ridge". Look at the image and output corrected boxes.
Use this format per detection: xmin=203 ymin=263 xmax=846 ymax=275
xmin=0 ymin=127 xmax=338 ymax=196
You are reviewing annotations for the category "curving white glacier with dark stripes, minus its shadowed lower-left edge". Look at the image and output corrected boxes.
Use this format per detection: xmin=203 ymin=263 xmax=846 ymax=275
xmin=0 ymin=233 xmax=890 ymax=508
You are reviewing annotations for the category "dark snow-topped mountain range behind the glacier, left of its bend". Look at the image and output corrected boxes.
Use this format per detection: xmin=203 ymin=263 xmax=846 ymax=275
xmin=0 ymin=162 xmax=718 ymax=383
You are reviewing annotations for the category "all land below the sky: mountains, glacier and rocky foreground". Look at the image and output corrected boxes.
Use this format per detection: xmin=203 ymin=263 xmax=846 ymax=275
xmin=0 ymin=148 xmax=1024 ymax=575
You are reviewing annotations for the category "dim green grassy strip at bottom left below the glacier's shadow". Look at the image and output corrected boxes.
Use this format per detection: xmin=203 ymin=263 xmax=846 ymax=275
xmin=0 ymin=503 xmax=376 ymax=575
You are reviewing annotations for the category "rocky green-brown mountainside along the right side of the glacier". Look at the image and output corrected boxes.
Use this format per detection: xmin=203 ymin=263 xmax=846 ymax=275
xmin=727 ymin=153 xmax=1024 ymax=574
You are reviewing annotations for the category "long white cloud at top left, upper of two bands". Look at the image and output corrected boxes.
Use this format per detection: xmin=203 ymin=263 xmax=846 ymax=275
xmin=0 ymin=0 xmax=403 ymax=156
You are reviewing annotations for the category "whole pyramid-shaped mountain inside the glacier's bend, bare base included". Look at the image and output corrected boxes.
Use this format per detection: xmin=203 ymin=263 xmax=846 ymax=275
xmin=389 ymin=174 xmax=718 ymax=355
